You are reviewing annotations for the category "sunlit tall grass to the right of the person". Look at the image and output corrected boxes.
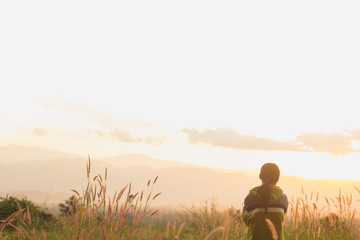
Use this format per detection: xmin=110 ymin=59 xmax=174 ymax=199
xmin=285 ymin=190 xmax=359 ymax=239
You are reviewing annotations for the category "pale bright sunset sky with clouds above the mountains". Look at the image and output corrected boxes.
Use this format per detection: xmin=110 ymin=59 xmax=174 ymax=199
xmin=0 ymin=0 xmax=360 ymax=179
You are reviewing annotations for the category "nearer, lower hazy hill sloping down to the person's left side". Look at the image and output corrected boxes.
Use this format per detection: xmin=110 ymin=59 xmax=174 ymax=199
xmin=0 ymin=159 xmax=256 ymax=205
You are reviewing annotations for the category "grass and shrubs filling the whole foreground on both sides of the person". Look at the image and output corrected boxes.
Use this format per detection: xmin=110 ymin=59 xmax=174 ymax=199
xmin=0 ymin=159 xmax=360 ymax=240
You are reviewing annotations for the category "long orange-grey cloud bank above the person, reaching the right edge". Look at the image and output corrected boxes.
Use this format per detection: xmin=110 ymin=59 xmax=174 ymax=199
xmin=183 ymin=128 xmax=360 ymax=156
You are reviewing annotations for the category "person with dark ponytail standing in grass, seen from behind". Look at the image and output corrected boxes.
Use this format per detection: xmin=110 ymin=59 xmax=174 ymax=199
xmin=242 ymin=163 xmax=289 ymax=240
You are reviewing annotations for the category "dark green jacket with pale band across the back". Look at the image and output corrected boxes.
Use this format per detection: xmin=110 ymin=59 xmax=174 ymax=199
xmin=242 ymin=185 xmax=289 ymax=240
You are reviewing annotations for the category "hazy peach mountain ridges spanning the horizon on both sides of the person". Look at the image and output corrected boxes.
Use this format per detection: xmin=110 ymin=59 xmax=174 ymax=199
xmin=0 ymin=144 xmax=360 ymax=210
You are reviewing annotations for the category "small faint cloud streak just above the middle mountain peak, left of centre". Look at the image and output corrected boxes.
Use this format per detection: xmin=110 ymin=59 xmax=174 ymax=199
xmin=88 ymin=128 xmax=166 ymax=145
